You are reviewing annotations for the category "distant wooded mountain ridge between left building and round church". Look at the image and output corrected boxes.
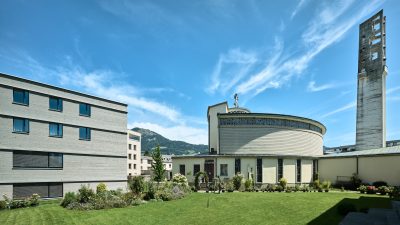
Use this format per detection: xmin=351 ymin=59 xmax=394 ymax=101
xmin=132 ymin=127 xmax=208 ymax=155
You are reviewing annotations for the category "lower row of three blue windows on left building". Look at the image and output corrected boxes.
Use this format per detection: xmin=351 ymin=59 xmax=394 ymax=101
xmin=13 ymin=118 xmax=91 ymax=141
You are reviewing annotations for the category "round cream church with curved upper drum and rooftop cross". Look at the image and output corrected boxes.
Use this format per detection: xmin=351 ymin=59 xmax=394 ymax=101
xmin=173 ymin=102 xmax=326 ymax=184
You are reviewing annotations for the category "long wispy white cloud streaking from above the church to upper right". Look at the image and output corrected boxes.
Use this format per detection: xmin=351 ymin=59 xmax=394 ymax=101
xmin=208 ymin=0 xmax=382 ymax=101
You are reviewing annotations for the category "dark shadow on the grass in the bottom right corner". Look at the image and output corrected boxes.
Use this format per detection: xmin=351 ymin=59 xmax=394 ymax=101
xmin=307 ymin=196 xmax=391 ymax=225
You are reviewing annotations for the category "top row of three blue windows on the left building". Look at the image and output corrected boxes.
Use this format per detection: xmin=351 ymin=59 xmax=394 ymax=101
xmin=13 ymin=88 xmax=91 ymax=117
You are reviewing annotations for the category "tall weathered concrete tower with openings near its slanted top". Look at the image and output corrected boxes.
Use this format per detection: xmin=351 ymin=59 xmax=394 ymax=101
xmin=356 ymin=10 xmax=387 ymax=150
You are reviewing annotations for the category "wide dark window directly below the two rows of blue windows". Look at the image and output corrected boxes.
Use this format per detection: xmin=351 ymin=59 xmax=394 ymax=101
xmin=13 ymin=151 xmax=63 ymax=168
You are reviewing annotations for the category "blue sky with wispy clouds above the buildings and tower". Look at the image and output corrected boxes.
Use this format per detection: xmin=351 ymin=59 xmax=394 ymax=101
xmin=0 ymin=0 xmax=400 ymax=146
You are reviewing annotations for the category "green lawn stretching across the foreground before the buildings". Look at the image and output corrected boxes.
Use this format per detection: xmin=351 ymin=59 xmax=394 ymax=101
xmin=0 ymin=192 xmax=390 ymax=225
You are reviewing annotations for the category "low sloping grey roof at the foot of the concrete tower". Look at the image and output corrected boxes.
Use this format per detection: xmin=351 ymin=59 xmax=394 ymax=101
xmin=321 ymin=146 xmax=400 ymax=158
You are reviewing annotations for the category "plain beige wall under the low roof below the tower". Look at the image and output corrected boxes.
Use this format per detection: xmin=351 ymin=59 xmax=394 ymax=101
xmin=318 ymin=155 xmax=400 ymax=186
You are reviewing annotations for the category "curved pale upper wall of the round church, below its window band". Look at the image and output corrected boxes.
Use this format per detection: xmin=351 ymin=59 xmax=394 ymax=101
xmin=219 ymin=126 xmax=323 ymax=156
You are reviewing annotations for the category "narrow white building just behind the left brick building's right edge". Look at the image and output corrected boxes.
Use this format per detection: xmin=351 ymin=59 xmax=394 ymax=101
xmin=127 ymin=130 xmax=141 ymax=176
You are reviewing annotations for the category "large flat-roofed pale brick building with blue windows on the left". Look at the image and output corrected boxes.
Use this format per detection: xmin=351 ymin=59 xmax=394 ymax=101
xmin=0 ymin=73 xmax=127 ymax=198
